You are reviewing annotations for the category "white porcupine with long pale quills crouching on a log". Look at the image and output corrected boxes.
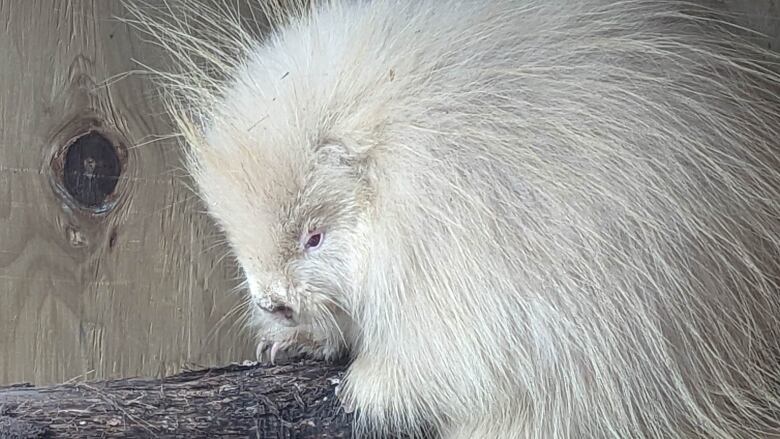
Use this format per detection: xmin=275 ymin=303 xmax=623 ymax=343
xmin=123 ymin=0 xmax=780 ymax=439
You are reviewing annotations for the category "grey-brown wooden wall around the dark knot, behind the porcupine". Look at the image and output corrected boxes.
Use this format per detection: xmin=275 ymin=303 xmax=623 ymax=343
xmin=0 ymin=0 xmax=780 ymax=384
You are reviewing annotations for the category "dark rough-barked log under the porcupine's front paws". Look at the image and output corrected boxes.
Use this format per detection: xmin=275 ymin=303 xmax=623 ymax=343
xmin=0 ymin=359 xmax=351 ymax=439
